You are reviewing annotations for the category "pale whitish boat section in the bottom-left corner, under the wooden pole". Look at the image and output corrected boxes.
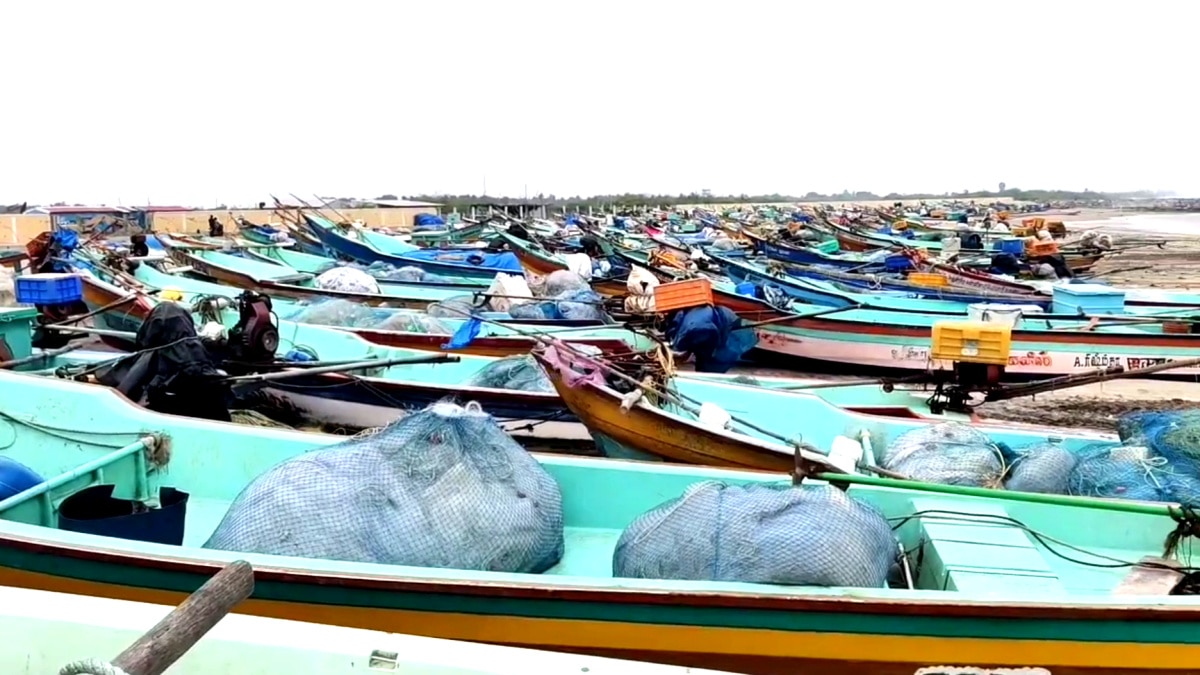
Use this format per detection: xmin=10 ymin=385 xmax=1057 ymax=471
xmin=9 ymin=586 xmax=715 ymax=675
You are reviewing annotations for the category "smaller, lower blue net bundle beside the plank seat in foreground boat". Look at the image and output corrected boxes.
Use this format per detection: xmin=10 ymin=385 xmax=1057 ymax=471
xmin=612 ymin=480 xmax=899 ymax=589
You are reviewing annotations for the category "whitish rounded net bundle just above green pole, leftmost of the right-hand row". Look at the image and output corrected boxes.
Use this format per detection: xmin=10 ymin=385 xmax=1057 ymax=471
xmin=880 ymin=422 xmax=1007 ymax=488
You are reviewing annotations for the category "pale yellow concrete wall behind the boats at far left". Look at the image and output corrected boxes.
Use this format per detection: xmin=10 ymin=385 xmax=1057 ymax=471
xmin=0 ymin=208 xmax=437 ymax=245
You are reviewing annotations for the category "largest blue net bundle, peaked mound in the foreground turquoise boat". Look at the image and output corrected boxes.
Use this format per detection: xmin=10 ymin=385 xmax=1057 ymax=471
xmin=204 ymin=402 xmax=563 ymax=573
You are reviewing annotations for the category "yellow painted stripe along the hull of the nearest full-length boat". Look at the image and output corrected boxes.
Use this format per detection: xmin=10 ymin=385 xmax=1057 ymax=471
xmin=0 ymin=569 xmax=1200 ymax=670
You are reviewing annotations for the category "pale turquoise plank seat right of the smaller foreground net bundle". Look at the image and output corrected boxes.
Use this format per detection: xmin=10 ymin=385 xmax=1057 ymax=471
xmin=912 ymin=497 xmax=1067 ymax=596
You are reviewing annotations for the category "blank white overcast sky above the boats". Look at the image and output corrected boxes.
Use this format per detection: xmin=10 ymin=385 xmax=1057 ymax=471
xmin=0 ymin=0 xmax=1200 ymax=205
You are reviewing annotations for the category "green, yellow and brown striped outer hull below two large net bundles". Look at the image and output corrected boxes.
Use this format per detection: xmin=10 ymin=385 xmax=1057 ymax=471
xmin=0 ymin=545 xmax=1200 ymax=675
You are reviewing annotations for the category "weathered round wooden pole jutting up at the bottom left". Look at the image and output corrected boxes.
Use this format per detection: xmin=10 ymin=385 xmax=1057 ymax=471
xmin=113 ymin=560 xmax=254 ymax=675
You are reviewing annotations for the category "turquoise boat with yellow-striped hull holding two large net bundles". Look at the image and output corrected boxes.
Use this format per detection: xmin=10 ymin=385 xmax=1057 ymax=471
xmin=0 ymin=372 xmax=1200 ymax=675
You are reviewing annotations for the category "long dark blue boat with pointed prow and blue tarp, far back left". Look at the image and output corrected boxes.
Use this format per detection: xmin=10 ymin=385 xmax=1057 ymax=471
xmin=302 ymin=214 xmax=522 ymax=281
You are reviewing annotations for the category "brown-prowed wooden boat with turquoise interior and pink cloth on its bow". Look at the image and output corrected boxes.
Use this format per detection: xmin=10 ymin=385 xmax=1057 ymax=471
xmin=535 ymin=348 xmax=1116 ymax=472
